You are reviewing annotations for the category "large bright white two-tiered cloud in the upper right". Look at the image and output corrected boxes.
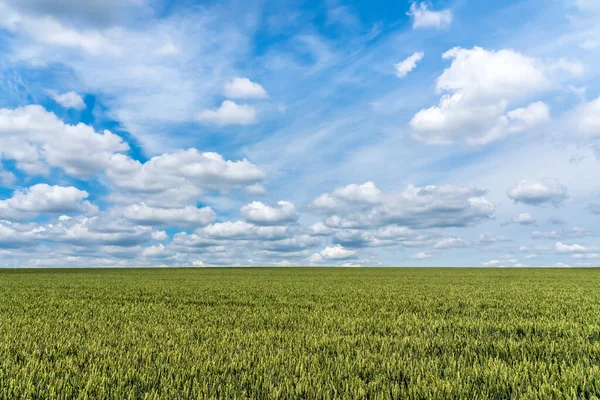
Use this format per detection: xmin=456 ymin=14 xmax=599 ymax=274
xmin=410 ymin=47 xmax=578 ymax=145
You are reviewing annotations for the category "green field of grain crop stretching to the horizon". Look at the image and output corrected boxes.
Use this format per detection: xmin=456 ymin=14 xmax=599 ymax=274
xmin=0 ymin=268 xmax=600 ymax=399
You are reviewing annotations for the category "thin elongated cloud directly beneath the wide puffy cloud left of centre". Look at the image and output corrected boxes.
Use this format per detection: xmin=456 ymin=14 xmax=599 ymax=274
xmin=123 ymin=203 xmax=217 ymax=227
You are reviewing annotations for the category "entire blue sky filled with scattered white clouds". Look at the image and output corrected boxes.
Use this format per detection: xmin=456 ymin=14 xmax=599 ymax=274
xmin=0 ymin=0 xmax=600 ymax=267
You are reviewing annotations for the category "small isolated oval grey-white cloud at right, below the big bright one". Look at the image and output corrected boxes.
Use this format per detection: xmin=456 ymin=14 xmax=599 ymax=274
xmin=506 ymin=178 xmax=568 ymax=206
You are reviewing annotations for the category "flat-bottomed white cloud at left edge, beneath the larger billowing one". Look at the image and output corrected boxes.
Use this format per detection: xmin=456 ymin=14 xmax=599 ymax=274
xmin=0 ymin=183 xmax=96 ymax=219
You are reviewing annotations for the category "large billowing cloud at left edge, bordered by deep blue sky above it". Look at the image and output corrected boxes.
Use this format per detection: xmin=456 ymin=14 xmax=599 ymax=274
xmin=0 ymin=105 xmax=129 ymax=178
